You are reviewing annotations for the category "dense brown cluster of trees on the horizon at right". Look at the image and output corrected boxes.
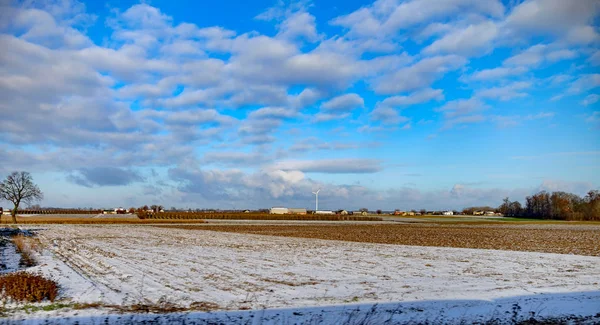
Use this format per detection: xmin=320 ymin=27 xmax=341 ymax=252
xmin=498 ymin=190 xmax=600 ymax=221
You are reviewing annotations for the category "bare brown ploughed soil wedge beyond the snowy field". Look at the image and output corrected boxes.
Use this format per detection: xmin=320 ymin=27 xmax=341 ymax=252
xmin=161 ymin=224 xmax=600 ymax=256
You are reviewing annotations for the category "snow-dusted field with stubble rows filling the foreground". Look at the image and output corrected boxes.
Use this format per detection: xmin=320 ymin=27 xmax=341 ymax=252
xmin=8 ymin=225 xmax=600 ymax=324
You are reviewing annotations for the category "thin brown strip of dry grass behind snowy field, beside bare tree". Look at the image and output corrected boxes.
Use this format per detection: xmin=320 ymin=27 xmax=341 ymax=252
xmin=0 ymin=216 xmax=205 ymax=225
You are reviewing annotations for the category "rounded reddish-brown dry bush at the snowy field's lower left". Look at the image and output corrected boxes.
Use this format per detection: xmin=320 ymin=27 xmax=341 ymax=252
xmin=0 ymin=271 xmax=58 ymax=302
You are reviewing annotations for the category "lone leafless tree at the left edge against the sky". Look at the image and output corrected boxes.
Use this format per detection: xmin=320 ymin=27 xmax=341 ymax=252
xmin=0 ymin=171 xmax=44 ymax=223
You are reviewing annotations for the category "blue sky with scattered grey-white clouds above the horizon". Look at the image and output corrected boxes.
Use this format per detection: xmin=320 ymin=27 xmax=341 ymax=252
xmin=0 ymin=0 xmax=600 ymax=210
